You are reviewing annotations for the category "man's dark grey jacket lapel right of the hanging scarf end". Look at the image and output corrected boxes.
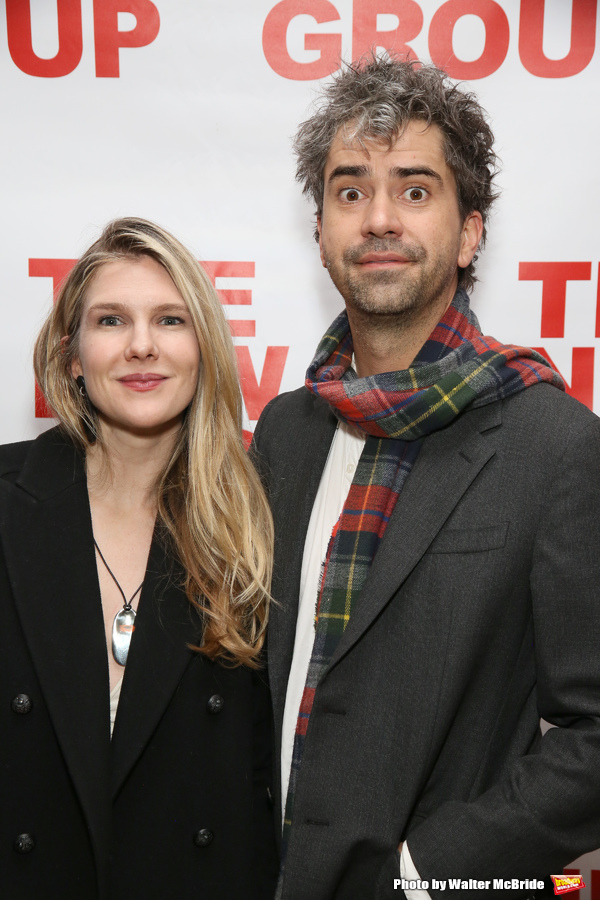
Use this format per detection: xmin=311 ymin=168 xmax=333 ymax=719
xmin=330 ymin=403 xmax=501 ymax=668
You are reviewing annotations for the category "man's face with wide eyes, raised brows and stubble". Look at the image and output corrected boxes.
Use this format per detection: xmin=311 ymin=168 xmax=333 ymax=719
xmin=318 ymin=121 xmax=481 ymax=316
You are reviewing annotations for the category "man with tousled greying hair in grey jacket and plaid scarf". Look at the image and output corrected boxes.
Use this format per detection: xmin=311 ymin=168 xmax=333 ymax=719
xmin=255 ymin=59 xmax=600 ymax=900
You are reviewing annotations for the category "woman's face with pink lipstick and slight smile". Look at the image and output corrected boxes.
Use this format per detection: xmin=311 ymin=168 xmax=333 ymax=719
xmin=72 ymin=256 xmax=200 ymax=435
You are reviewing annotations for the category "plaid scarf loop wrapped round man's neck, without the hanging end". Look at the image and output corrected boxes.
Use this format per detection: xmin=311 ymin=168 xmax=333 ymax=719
xmin=305 ymin=289 xmax=564 ymax=441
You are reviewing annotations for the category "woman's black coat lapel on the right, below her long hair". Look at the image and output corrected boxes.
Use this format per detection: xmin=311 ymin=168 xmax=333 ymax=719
xmin=112 ymin=541 xmax=201 ymax=797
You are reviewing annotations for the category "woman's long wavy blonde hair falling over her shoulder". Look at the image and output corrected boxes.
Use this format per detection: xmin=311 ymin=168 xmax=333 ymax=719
xmin=34 ymin=218 xmax=273 ymax=667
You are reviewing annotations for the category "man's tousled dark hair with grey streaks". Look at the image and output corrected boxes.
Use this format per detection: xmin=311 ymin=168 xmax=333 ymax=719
xmin=294 ymin=54 xmax=498 ymax=290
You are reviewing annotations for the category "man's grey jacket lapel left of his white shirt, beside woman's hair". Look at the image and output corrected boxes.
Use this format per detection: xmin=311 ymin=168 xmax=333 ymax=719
xmin=268 ymin=398 xmax=337 ymax=728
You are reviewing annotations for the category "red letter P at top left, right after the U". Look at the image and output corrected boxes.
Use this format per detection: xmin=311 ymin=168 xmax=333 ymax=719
xmin=94 ymin=0 xmax=160 ymax=78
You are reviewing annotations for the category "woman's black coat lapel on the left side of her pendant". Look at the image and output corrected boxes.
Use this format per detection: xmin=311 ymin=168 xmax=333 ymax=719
xmin=0 ymin=429 xmax=110 ymax=849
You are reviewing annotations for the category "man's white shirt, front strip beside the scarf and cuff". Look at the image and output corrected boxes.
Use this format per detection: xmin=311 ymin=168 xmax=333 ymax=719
xmin=281 ymin=422 xmax=430 ymax=900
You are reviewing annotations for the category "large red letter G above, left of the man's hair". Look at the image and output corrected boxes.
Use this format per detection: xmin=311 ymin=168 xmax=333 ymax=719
xmin=262 ymin=0 xmax=342 ymax=81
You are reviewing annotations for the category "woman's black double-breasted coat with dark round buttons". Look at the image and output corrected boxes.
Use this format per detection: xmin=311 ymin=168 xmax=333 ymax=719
xmin=0 ymin=430 xmax=276 ymax=900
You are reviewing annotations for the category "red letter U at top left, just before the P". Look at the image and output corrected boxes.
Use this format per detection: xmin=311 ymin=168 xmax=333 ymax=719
xmin=6 ymin=0 xmax=83 ymax=78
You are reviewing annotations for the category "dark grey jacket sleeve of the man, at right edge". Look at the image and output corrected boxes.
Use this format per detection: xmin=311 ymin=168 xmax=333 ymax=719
xmin=408 ymin=420 xmax=600 ymax=900
